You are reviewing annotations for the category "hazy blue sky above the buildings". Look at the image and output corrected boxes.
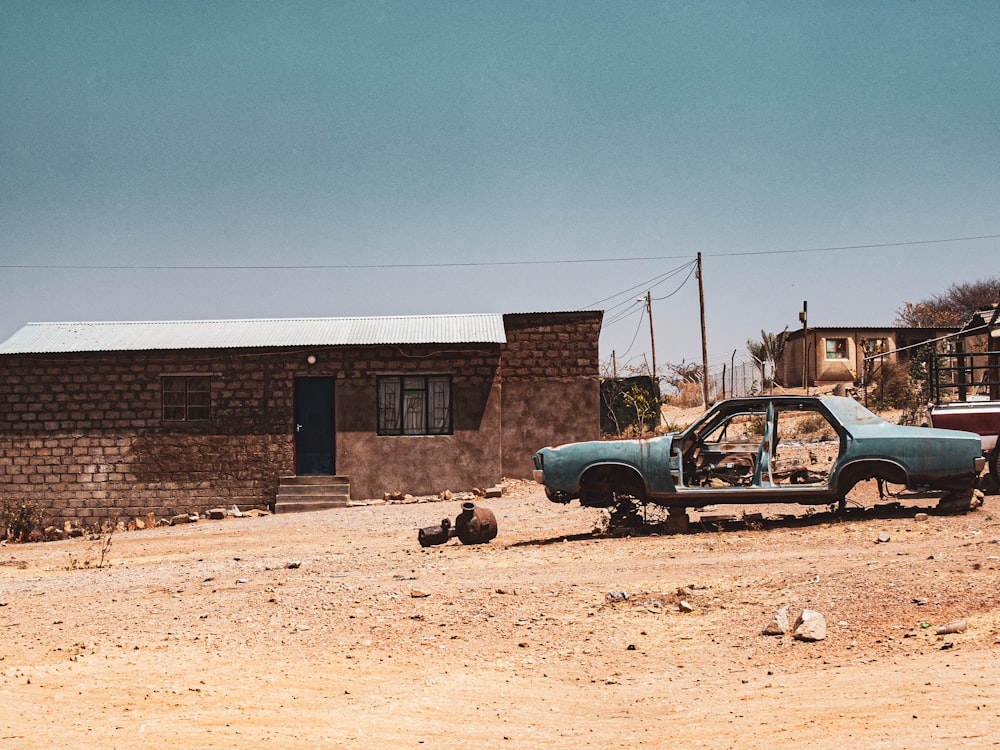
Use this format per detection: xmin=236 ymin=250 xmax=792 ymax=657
xmin=0 ymin=0 xmax=1000 ymax=382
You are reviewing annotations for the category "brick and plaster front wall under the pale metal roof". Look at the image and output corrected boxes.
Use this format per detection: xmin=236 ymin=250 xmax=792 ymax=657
xmin=0 ymin=345 xmax=508 ymax=524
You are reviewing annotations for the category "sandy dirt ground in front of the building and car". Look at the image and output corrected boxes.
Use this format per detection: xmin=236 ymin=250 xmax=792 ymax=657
xmin=0 ymin=482 xmax=1000 ymax=749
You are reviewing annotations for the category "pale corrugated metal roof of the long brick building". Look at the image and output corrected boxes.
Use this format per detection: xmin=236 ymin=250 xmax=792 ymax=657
xmin=0 ymin=314 xmax=507 ymax=354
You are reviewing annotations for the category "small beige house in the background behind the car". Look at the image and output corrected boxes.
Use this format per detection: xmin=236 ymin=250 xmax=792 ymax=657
xmin=775 ymin=326 xmax=958 ymax=388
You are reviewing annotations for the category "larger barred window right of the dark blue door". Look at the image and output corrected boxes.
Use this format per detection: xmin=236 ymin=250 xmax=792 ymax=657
xmin=378 ymin=375 xmax=452 ymax=435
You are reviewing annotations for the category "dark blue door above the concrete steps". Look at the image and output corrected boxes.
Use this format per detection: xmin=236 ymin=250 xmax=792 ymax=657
xmin=295 ymin=378 xmax=336 ymax=476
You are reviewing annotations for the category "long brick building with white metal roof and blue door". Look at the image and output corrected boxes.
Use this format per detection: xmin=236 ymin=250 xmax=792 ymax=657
xmin=0 ymin=311 xmax=602 ymax=523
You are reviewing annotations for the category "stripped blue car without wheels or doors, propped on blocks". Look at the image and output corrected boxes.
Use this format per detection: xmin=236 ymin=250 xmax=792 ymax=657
xmin=534 ymin=396 xmax=985 ymax=512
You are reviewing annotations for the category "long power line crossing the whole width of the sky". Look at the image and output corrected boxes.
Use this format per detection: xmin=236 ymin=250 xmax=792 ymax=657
xmin=0 ymin=234 xmax=1000 ymax=271
